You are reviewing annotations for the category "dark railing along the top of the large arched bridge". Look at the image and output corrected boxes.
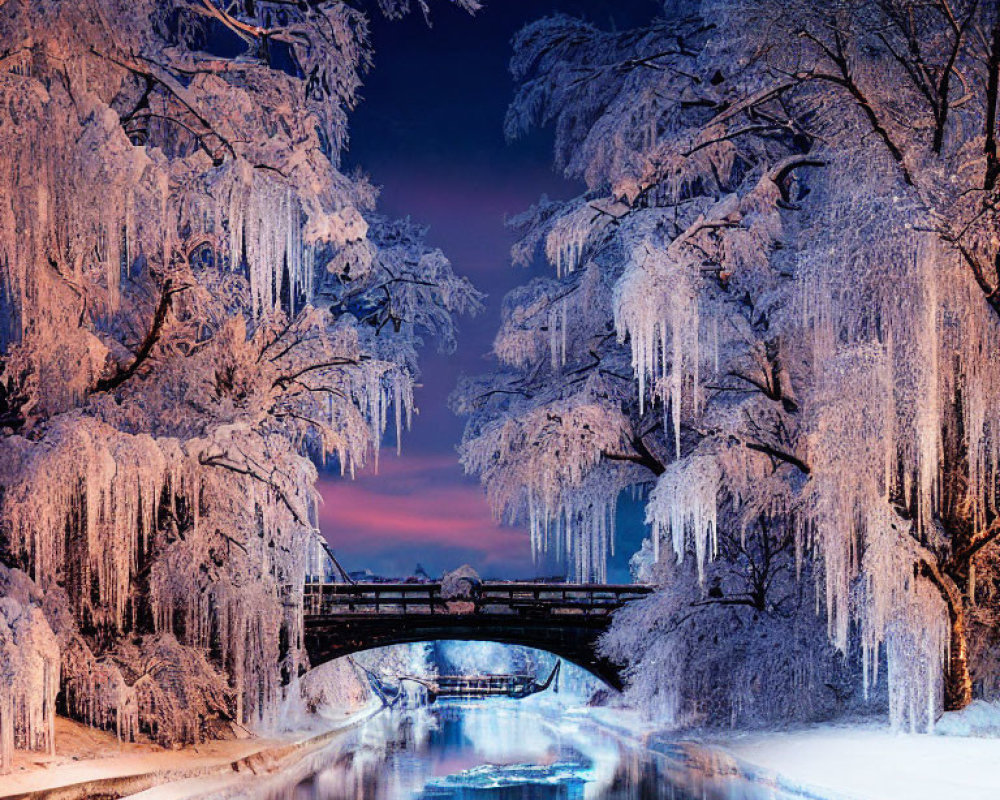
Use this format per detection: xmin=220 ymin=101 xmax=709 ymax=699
xmin=303 ymin=581 xmax=652 ymax=617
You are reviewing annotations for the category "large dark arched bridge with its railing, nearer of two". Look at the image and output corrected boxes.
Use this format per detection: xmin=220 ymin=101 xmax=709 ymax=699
xmin=304 ymin=581 xmax=652 ymax=690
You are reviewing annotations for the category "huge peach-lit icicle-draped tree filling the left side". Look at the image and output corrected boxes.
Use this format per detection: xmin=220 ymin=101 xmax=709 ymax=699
xmin=0 ymin=0 xmax=479 ymax=759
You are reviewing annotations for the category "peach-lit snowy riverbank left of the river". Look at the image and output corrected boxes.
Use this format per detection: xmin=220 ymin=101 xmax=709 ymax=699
xmin=0 ymin=704 xmax=380 ymax=800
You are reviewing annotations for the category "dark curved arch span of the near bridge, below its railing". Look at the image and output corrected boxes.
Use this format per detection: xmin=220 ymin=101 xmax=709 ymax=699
xmin=305 ymin=613 xmax=623 ymax=691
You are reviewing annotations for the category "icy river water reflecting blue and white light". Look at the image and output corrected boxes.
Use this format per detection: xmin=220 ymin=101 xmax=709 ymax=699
xmin=257 ymin=699 xmax=796 ymax=800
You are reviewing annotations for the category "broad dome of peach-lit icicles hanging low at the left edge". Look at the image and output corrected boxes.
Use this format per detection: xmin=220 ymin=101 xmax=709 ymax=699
xmin=3 ymin=415 xmax=191 ymax=630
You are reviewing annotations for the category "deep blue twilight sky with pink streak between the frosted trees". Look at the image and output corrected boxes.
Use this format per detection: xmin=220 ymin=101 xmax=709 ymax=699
xmin=320 ymin=0 xmax=659 ymax=580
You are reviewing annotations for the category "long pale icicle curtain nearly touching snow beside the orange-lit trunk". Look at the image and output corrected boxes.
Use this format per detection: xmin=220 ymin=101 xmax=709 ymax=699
xmin=805 ymin=347 xmax=950 ymax=730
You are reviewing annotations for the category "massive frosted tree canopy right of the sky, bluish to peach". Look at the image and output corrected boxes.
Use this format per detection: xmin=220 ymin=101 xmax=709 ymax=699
xmin=456 ymin=0 xmax=1000 ymax=726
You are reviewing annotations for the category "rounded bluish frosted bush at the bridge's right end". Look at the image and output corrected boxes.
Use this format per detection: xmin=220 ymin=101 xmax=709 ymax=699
xmin=601 ymin=534 xmax=868 ymax=728
